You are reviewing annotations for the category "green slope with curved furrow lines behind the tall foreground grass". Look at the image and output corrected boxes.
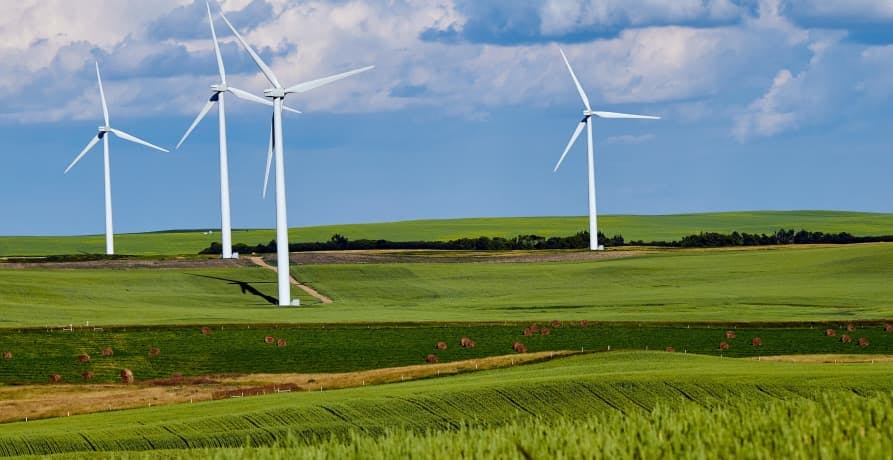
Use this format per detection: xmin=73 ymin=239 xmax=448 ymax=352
xmin=0 ymin=352 xmax=893 ymax=455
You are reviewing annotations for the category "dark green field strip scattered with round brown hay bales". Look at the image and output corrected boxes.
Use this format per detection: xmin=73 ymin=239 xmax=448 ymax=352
xmin=0 ymin=322 xmax=893 ymax=384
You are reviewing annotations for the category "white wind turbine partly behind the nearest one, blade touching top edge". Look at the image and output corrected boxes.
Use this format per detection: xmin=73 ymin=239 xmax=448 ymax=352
xmin=177 ymin=3 xmax=300 ymax=259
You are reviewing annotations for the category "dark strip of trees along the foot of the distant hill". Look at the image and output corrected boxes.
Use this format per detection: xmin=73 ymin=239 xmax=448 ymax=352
xmin=200 ymin=229 xmax=893 ymax=254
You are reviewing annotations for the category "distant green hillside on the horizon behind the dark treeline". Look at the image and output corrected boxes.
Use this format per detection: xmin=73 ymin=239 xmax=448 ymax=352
xmin=0 ymin=211 xmax=893 ymax=256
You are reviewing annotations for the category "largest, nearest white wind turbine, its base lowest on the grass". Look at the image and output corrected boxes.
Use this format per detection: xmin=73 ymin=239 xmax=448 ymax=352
xmin=220 ymin=8 xmax=375 ymax=306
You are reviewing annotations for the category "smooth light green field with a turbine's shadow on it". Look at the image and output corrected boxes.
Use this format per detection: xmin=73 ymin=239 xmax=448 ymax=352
xmin=0 ymin=244 xmax=893 ymax=327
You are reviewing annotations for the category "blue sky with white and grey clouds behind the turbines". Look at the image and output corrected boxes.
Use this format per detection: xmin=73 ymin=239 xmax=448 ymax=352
xmin=0 ymin=0 xmax=893 ymax=235
